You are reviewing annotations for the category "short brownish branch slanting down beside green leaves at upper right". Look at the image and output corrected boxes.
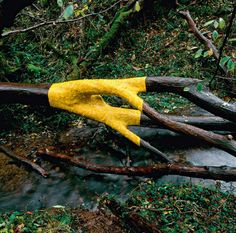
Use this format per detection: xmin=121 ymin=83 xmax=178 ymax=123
xmin=179 ymin=11 xmax=228 ymax=74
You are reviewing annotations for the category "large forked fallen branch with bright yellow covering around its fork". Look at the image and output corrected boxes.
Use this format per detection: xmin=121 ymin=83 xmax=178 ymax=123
xmin=0 ymin=77 xmax=236 ymax=158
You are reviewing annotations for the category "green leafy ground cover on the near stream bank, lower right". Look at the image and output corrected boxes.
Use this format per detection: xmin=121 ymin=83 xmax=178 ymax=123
xmin=106 ymin=183 xmax=236 ymax=232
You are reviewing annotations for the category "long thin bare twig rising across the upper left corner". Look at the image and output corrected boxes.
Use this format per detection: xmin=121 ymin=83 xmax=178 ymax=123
xmin=2 ymin=0 xmax=122 ymax=37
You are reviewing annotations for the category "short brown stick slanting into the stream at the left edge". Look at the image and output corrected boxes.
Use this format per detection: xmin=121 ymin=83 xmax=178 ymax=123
xmin=0 ymin=146 xmax=48 ymax=178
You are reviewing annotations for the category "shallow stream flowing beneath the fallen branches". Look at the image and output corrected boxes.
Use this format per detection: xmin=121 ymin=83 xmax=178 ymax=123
xmin=0 ymin=129 xmax=236 ymax=212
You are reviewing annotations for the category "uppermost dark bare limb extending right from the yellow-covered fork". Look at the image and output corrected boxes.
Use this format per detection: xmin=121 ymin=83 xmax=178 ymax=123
xmin=146 ymin=77 xmax=236 ymax=123
